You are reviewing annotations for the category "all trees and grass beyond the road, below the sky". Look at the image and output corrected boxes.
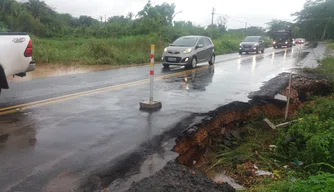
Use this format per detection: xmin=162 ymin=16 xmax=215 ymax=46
xmin=0 ymin=0 xmax=334 ymax=64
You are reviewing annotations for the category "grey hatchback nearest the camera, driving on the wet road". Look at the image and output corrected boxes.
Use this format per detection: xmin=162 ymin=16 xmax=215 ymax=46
xmin=161 ymin=36 xmax=216 ymax=68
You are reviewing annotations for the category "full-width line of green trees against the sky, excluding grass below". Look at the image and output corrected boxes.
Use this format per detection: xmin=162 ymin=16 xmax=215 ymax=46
xmin=0 ymin=0 xmax=334 ymax=40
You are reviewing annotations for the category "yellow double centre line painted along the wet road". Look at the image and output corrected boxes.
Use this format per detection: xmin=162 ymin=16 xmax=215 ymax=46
xmin=0 ymin=51 xmax=290 ymax=116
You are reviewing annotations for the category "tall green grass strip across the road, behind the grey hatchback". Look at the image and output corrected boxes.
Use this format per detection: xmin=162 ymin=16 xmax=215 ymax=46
xmin=33 ymin=34 xmax=244 ymax=65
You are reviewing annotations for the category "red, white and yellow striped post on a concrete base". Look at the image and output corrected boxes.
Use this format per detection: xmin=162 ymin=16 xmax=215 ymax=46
xmin=139 ymin=45 xmax=162 ymax=110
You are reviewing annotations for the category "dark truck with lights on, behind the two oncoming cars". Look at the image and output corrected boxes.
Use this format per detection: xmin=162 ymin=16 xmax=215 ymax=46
xmin=272 ymin=29 xmax=293 ymax=49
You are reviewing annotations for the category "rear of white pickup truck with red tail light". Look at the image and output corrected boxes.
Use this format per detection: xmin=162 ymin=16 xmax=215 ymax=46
xmin=0 ymin=32 xmax=36 ymax=93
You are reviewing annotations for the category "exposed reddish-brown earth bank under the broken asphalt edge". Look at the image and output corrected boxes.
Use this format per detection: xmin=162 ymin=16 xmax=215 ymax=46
xmin=173 ymin=73 xmax=330 ymax=167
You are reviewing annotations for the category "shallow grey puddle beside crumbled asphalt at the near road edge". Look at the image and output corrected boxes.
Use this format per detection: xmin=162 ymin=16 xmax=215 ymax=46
xmin=109 ymin=138 xmax=178 ymax=192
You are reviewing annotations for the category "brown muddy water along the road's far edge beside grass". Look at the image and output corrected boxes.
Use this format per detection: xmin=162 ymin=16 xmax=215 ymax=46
xmin=8 ymin=64 xmax=145 ymax=82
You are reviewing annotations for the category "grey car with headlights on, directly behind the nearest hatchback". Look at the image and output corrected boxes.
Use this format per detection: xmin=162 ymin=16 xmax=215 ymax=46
xmin=239 ymin=36 xmax=266 ymax=55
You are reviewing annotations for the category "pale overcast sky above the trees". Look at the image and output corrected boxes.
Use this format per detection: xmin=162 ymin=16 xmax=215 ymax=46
xmin=44 ymin=0 xmax=306 ymax=28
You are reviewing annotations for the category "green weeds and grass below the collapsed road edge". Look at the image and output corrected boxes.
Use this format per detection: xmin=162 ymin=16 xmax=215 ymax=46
xmin=206 ymin=95 xmax=334 ymax=192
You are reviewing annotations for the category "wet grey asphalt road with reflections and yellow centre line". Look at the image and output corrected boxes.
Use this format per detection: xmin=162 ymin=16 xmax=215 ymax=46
xmin=0 ymin=44 xmax=325 ymax=191
